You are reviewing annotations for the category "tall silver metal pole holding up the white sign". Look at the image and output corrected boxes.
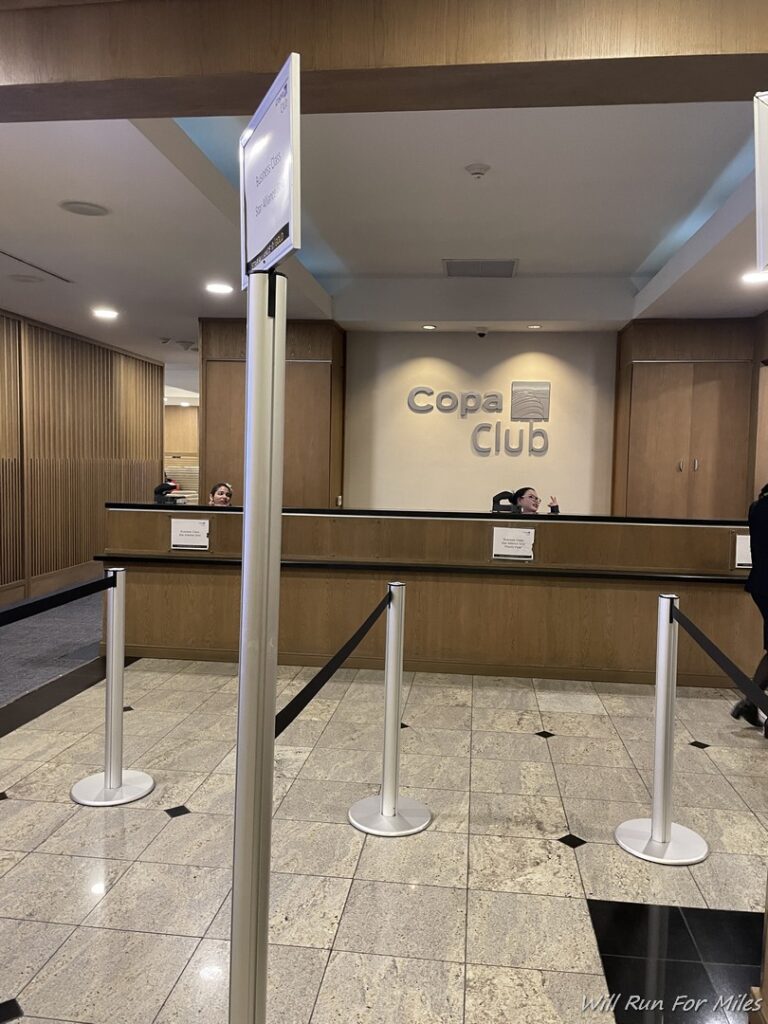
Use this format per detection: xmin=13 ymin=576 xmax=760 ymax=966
xmin=229 ymin=271 xmax=286 ymax=1024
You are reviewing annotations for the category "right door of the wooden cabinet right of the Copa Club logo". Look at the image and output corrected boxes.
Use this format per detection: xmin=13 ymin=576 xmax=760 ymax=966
xmin=688 ymin=362 xmax=752 ymax=519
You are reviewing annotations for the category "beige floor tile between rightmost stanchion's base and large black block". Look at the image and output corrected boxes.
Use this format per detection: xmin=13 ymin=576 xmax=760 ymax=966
xmin=575 ymin=843 xmax=705 ymax=906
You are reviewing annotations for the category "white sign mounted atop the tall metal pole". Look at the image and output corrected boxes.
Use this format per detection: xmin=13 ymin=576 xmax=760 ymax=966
xmin=240 ymin=53 xmax=301 ymax=280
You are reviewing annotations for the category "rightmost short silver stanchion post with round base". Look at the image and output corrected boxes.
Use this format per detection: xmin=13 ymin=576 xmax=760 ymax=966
xmin=614 ymin=594 xmax=710 ymax=865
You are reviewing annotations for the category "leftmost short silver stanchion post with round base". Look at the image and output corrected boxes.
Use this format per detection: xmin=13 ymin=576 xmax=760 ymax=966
xmin=70 ymin=569 xmax=155 ymax=807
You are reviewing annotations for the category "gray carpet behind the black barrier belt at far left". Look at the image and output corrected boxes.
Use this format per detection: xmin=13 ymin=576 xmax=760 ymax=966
xmin=0 ymin=594 xmax=103 ymax=708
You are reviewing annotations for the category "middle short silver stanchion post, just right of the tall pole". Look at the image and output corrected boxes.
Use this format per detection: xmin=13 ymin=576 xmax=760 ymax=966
xmin=347 ymin=583 xmax=432 ymax=836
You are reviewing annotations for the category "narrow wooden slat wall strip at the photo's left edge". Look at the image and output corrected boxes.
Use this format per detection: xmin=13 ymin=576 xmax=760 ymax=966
xmin=0 ymin=316 xmax=24 ymax=596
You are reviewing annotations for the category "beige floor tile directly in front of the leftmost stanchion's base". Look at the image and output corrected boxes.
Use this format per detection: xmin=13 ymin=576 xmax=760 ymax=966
xmin=40 ymin=804 xmax=169 ymax=860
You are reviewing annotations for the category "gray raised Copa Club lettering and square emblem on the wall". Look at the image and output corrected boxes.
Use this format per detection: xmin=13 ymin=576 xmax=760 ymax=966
xmin=408 ymin=381 xmax=552 ymax=458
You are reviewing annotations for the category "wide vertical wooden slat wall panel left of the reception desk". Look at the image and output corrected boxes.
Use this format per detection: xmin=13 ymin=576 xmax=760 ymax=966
xmin=6 ymin=321 xmax=163 ymax=593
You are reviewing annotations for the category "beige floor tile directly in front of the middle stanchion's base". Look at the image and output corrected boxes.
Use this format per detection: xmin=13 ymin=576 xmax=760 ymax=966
xmin=354 ymin=828 xmax=467 ymax=888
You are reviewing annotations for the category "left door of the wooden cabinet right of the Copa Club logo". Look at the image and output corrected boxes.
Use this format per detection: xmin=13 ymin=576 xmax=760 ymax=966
xmin=627 ymin=362 xmax=693 ymax=518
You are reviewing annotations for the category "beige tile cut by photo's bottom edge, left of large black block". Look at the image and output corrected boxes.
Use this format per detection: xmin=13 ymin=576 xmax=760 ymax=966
xmin=464 ymin=964 xmax=612 ymax=1024
